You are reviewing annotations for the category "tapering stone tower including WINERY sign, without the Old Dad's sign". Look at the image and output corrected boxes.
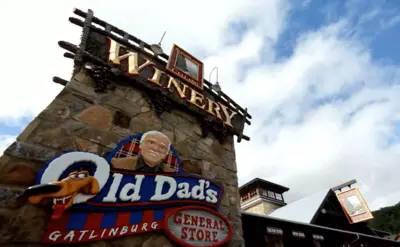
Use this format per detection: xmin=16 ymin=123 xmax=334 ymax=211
xmin=0 ymin=9 xmax=250 ymax=247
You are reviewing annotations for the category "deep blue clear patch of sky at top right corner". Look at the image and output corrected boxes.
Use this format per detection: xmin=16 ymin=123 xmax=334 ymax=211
xmin=275 ymin=0 xmax=400 ymax=64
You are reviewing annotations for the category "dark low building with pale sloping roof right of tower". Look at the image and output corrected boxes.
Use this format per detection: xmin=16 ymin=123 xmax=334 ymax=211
xmin=240 ymin=179 xmax=400 ymax=247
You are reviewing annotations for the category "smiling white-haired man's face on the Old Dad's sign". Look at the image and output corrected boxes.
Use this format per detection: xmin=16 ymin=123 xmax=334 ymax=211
xmin=139 ymin=135 xmax=170 ymax=167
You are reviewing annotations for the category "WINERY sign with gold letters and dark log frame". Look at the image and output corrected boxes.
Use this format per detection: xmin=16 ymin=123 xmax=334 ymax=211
xmin=70 ymin=11 xmax=251 ymax=142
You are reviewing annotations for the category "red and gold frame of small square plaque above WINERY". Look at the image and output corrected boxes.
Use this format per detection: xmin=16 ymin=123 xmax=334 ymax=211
xmin=167 ymin=44 xmax=204 ymax=91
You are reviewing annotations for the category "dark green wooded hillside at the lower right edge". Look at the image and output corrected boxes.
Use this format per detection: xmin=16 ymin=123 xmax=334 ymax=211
xmin=370 ymin=202 xmax=400 ymax=234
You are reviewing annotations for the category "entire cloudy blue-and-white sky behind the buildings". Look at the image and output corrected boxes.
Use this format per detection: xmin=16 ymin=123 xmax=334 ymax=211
xmin=0 ymin=0 xmax=400 ymax=210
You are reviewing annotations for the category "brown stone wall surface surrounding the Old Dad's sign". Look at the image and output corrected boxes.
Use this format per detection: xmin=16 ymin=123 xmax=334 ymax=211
xmin=0 ymin=72 xmax=244 ymax=247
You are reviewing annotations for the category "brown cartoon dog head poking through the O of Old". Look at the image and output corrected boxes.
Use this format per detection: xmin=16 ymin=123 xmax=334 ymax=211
xmin=25 ymin=171 xmax=99 ymax=220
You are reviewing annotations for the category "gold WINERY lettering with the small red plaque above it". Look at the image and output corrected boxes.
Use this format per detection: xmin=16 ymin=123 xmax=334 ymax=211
xmin=107 ymin=38 xmax=240 ymax=127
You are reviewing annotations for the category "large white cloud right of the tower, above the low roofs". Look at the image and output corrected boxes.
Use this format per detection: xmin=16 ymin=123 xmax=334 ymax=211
xmin=235 ymin=22 xmax=400 ymax=208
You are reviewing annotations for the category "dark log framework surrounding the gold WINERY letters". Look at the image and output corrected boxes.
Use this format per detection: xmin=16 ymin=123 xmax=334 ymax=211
xmin=61 ymin=9 xmax=251 ymax=142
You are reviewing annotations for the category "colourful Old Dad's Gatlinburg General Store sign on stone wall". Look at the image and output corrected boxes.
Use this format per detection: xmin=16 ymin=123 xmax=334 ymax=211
xmin=25 ymin=131 xmax=231 ymax=246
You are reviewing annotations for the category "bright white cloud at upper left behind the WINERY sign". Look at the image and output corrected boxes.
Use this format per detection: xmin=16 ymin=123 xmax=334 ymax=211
xmin=0 ymin=0 xmax=286 ymax=121
